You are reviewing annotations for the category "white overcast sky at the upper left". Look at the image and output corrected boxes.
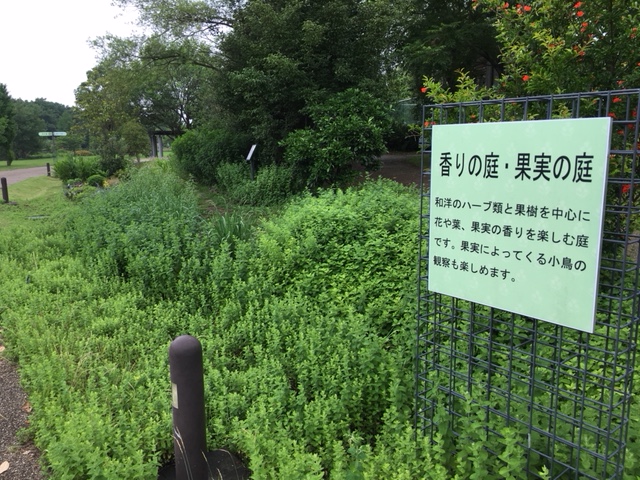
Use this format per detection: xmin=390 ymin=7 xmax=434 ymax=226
xmin=0 ymin=0 xmax=135 ymax=106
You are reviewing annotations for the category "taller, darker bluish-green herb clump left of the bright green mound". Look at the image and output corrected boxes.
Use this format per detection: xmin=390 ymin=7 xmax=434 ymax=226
xmin=69 ymin=165 xmax=201 ymax=300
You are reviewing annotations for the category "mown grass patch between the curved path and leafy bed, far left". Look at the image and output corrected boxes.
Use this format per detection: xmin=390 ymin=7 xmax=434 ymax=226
xmin=0 ymin=175 xmax=69 ymax=229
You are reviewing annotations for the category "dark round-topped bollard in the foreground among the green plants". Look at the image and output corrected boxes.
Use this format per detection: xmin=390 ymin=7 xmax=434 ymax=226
xmin=169 ymin=335 xmax=208 ymax=480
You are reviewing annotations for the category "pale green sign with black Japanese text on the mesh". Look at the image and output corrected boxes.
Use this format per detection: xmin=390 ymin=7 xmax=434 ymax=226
xmin=429 ymin=118 xmax=611 ymax=332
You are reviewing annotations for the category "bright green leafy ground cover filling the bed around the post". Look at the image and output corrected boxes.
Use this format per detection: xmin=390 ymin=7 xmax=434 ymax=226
xmin=0 ymin=164 xmax=633 ymax=480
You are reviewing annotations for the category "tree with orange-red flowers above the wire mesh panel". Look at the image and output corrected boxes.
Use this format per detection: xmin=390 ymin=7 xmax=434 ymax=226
xmin=474 ymin=0 xmax=640 ymax=95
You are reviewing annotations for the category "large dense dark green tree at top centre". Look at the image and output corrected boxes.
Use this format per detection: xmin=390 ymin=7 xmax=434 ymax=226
xmin=218 ymin=0 xmax=400 ymax=157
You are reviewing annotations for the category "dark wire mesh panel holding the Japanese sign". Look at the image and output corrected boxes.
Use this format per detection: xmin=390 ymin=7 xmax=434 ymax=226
xmin=416 ymin=90 xmax=640 ymax=479
